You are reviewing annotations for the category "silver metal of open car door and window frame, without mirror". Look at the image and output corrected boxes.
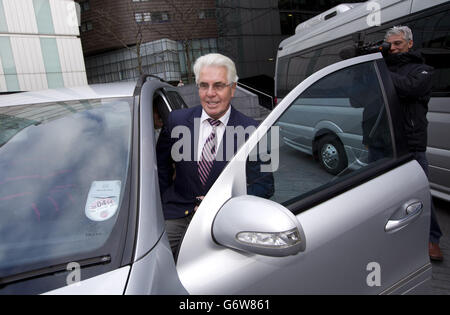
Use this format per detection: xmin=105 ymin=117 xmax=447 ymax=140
xmin=177 ymin=54 xmax=431 ymax=294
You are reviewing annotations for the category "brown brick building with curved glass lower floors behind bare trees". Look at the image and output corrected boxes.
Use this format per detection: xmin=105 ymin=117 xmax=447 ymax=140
xmin=77 ymin=0 xmax=217 ymax=83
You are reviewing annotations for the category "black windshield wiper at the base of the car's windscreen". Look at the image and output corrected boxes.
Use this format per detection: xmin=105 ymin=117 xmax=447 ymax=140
xmin=0 ymin=255 xmax=111 ymax=288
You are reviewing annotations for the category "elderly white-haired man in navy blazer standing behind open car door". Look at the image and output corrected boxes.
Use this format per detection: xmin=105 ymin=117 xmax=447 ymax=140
xmin=156 ymin=54 xmax=274 ymax=257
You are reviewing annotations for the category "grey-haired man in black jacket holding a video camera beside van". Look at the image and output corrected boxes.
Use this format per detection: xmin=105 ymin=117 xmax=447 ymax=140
xmin=384 ymin=26 xmax=443 ymax=261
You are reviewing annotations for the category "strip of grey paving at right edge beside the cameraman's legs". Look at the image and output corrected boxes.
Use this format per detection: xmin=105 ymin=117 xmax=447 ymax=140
xmin=430 ymin=198 xmax=450 ymax=295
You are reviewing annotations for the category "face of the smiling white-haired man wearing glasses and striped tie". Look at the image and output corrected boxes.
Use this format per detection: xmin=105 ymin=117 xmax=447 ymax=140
xmin=198 ymin=66 xmax=236 ymax=119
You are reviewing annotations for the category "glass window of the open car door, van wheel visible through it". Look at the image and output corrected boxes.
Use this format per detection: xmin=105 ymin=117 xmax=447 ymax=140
xmin=247 ymin=62 xmax=393 ymax=210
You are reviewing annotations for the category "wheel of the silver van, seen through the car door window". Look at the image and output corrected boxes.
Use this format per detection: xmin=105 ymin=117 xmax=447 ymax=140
xmin=317 ymin=135 xmax=348 ymax=175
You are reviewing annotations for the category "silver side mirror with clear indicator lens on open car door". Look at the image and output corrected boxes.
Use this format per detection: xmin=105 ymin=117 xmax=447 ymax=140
xmin=212 ymin=195 xmax=306 ymax=257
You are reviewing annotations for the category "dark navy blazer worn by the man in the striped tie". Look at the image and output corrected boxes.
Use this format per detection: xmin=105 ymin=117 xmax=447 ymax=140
xmin=156 ymin=106 xmax=274 ymax=219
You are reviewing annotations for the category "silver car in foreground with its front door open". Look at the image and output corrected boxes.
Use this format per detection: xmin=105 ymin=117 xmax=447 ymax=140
xmin=0 ymin=54 xmax=431 ymax=295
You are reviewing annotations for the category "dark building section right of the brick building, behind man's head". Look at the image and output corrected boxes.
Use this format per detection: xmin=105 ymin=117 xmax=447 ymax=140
xmin=216 ymin=0 xmax=283 ymax=89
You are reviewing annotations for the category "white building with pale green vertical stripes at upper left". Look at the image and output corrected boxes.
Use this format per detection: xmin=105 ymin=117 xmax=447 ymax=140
xmin=0 ymin=0 xmax=87 ymax=92
